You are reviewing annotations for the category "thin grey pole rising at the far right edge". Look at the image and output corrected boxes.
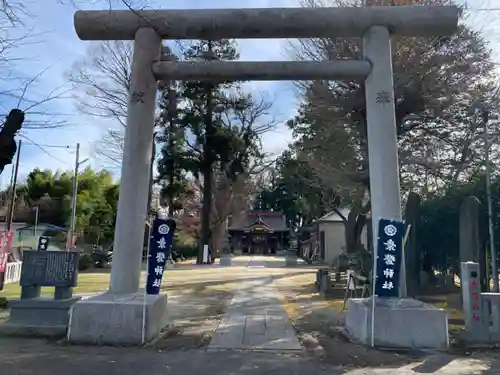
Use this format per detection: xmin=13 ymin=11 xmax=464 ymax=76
xmin=482 ymin=108 xmax=499 ymax=293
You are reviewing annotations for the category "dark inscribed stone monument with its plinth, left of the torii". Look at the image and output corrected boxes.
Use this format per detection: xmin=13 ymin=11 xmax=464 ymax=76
xmin=1 ymin=251 xmax=80 ymax=337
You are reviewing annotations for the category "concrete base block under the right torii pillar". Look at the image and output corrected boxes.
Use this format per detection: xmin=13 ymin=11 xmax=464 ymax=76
xmin=346 ymin=297 xmax=449 ymax=349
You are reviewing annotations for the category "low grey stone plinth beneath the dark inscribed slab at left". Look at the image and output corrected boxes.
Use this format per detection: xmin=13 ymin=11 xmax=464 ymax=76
xmin=0 ymin=297 xmax=81 ymax=337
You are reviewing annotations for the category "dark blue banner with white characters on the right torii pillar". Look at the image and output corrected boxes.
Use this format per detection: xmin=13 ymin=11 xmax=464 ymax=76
xmin=375 ymin=219 xmax=405 ymax=298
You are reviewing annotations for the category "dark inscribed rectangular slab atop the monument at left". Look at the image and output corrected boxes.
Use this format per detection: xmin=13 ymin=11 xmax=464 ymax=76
xmin=19 ymin=251 xmax=80 ymax=287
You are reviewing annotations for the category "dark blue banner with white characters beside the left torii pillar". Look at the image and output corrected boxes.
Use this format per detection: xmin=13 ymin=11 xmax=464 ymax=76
xmin=146 ymin=218 xmax=175 ymax=294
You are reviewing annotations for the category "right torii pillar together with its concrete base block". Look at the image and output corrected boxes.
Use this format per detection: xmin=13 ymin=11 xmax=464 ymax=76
xmin=346 ymin=25 xmax=449 ymax=349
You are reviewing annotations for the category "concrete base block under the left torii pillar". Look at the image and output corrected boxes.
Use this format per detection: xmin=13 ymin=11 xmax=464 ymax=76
xmin=68 ymin=292 xmax=167 ymax=345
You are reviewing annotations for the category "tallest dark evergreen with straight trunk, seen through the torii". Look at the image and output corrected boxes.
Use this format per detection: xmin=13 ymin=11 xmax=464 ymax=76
xmin=159 ymin=40 xmax=271 ymax=262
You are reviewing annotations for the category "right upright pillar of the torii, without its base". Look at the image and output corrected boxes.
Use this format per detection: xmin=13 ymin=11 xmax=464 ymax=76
xmin=363 ymin=26 xmax=406 ymax=293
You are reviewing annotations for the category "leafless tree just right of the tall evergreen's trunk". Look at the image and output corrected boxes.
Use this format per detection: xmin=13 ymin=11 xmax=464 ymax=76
xmin=182 ymin=92 xmax=277 ymax=254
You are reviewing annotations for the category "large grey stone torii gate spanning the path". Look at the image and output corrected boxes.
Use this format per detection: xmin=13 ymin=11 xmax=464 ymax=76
xmin=70 ymin=6 xmax=459 ymax=344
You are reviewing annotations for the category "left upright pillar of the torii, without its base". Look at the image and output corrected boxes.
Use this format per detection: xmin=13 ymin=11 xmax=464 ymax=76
xmin=109 ymin=28 xmax=161 ymax=293
